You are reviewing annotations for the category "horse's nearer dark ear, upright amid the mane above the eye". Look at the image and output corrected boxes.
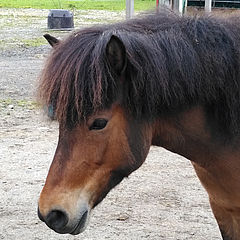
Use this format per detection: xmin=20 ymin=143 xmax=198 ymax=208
xmin=106 ymin=35 xmax=127 ymax=75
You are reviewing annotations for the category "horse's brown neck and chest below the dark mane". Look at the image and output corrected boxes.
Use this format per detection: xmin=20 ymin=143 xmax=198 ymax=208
xmin=152 ymin=107 xmax=240 ymax=240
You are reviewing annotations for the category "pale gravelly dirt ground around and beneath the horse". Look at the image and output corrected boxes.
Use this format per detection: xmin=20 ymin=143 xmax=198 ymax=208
xmin=0 ymin=9 xmax=230 ymax=240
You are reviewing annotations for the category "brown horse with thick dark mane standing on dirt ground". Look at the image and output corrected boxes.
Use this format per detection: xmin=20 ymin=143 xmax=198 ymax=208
xmin=38 ymin=9 xmax=240 ymax=240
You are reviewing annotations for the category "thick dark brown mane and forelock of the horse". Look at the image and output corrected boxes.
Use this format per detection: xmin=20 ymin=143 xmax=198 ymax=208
xmin=39 ymin=9 xmax=240 ymax=135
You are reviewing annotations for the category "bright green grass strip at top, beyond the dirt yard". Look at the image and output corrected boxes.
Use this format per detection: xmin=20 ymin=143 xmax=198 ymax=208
xmin=0 ymin=0 xmax=156 ymax=11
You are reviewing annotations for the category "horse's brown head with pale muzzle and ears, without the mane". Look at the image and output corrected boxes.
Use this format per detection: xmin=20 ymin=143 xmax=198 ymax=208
xmin=38 ymin=33 xmax=151 ymax=234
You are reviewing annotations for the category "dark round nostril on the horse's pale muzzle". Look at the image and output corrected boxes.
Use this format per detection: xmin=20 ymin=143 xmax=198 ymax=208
xmin=45 ymin=210 xmax=68 ymax=231
